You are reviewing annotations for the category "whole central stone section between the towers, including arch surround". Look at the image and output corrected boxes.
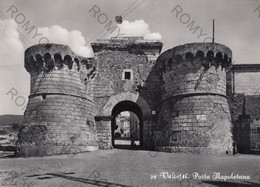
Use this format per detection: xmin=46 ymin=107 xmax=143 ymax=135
xmin=91 ymin=37 xmax=162 ymax=148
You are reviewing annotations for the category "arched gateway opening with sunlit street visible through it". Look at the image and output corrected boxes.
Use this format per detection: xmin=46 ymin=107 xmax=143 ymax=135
xmin=111 ymin=101 xmax=143 ymax=149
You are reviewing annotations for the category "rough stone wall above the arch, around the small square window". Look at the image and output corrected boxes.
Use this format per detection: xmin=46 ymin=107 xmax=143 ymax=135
xmin=92 ymin=37 xmax=162 ymax=115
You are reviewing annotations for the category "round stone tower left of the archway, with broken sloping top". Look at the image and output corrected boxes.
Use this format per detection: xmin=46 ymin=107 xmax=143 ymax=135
xmin=16 ymin=44 xmax=98 ymax=156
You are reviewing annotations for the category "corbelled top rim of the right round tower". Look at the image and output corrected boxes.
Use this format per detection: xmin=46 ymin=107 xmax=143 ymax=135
xmin=158 ymin=43 xmax=232 ymax=72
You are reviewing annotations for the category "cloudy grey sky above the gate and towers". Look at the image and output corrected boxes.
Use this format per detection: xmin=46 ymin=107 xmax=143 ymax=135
xmin=0 ymin=0 xmax=260 ymax=115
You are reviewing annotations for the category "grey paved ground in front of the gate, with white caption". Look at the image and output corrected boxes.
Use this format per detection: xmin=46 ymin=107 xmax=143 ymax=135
xmin=0 ymin=149 xmax=260 ymax=187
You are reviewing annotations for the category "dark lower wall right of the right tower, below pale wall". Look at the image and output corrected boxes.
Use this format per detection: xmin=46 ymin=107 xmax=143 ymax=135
xmin=229 ymin=94 xmax=260 ymax=153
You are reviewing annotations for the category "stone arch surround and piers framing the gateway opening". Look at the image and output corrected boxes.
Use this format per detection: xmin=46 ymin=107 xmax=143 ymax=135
xmin=95 ymin=92 xmax=152 ymax=149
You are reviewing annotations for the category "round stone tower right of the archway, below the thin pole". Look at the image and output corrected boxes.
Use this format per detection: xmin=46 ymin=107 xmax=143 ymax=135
xmin=155 ymin=43 xmax=232 ymax=154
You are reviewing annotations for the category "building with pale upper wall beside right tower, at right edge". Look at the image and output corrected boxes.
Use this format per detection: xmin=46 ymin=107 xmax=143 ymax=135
xmin=227 ymin=64 xmax=260 ymax=153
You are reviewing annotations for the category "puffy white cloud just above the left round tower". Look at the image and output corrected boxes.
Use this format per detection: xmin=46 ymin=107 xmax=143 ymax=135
xmin=35 ymin=25 xmax=93 ymax=57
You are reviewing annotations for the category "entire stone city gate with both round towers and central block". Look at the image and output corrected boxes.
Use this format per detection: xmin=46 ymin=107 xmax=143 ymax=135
xmin=16 ymin=37 xmax=233 ymax=156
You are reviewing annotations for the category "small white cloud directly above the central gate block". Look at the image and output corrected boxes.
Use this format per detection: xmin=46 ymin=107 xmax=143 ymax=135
xmin=110 ymin=20 xmax=162 ymax=40
